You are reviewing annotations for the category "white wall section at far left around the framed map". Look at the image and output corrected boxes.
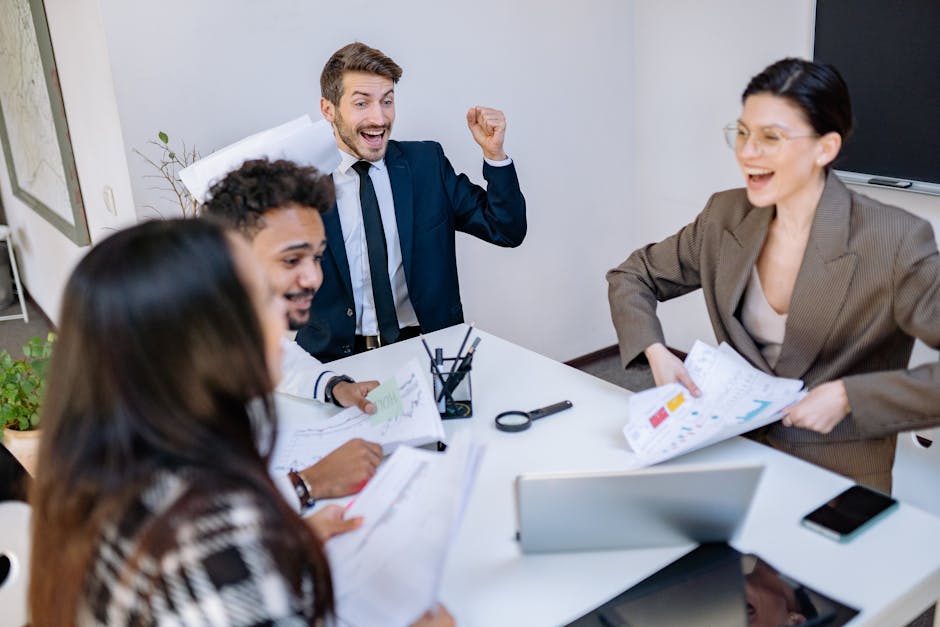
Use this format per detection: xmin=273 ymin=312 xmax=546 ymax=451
xmin=0 ymin=0 xmax=136 ymax=324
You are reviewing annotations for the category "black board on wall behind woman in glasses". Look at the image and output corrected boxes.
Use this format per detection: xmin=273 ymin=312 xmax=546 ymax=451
xmin=814 ymin=0 xmax=940 ymax=184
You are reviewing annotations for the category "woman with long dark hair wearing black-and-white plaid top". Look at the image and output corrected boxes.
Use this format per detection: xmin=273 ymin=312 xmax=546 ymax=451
xmin=29 ymin=220 xmax=449 ymax=627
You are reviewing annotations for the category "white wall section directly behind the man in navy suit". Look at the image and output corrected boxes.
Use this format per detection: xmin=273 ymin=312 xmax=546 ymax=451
xmin=102 ymin=0 xmax=637 ymax=359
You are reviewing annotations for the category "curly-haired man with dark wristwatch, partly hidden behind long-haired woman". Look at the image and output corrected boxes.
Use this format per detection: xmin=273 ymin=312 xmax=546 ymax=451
xmin=203 ymin=159 xmax=382 ymax=508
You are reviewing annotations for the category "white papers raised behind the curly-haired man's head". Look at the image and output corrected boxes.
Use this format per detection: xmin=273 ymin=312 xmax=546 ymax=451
xmin=179 ymin=115 xmax=341 ymax=204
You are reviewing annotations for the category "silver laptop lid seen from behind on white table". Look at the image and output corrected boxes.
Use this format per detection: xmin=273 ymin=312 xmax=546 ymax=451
xmin=515 ymin=464 xmax=764 ymax=553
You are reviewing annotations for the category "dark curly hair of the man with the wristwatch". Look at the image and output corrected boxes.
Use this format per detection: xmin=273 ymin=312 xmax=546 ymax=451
xmin=203 ymin=159 xmax=336 ymax=238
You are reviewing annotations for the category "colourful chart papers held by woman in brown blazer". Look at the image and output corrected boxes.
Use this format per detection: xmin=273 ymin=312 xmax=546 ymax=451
xmin=623 ymin=342 xmax=806 ymax=465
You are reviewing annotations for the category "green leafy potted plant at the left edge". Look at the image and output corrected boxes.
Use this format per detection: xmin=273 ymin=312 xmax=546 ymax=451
xmin=0 ymin=333 xmax=55 ymax=474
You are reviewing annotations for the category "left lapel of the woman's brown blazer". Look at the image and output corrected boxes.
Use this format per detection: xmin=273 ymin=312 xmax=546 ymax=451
xmin=715 ymin=207 xmax=774 ymax=372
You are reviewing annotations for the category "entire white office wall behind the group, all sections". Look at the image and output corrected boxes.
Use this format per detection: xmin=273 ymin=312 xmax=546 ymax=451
xmin=7 ymin=0 xmax=940 ymax=359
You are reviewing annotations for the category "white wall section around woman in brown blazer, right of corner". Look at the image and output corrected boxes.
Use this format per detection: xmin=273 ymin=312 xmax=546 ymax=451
xmin=634 ymin=0 xmax=940 ymax=368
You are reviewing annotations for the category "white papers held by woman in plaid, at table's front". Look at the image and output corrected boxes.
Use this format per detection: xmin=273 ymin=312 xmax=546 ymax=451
xmin=326 ymin=435 xmax=482 ymax=625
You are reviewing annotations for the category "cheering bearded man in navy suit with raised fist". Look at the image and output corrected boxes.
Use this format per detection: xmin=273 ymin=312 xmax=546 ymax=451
xmin=297 ymin=43 xmax=526 ymax=361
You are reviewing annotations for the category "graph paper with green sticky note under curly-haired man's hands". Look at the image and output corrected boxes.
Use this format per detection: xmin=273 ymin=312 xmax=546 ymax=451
xmin=268 ymin=359 xmax=444 ymax=502
